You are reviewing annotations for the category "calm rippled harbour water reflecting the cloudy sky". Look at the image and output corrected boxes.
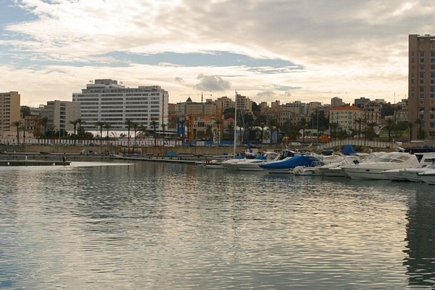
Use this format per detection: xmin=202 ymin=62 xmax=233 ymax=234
xmin=0 ymin=163 xmax=435 ymax=289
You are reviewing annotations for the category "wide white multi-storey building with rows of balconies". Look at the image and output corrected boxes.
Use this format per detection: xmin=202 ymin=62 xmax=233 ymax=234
xmin=72 ymin=79 xmax=169 ymax=130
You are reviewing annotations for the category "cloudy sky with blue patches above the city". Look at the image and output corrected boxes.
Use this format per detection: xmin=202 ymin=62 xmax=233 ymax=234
xmin=0 ymin=0 xmax=435 ymax=106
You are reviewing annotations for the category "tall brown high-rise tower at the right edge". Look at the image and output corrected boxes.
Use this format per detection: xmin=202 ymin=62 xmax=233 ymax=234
xmin=408 ymin=34 xmax=435 ymax=139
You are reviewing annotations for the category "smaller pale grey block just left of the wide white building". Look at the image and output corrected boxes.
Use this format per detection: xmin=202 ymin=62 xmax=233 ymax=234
xmin=41 ymin=100 xmax=84 ymax=132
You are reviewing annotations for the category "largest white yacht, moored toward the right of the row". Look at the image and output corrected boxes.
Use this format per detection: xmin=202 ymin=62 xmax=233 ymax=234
xmin=342 ymin=152 xmax=419 ymax=179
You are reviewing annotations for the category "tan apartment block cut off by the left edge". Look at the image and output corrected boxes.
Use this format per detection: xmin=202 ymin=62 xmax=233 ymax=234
xmin=0 ymin=92 xmax=21 ymax=138
